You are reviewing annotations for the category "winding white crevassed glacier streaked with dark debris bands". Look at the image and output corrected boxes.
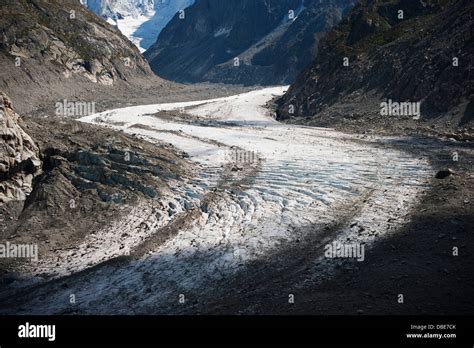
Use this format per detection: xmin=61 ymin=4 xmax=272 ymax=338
xmin=0 ymin=86 xmax=433 ymax=315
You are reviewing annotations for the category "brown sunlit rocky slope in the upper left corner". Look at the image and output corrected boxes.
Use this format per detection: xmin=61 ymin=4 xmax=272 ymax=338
xmin=0 ymin=0 xmax=161 ymax=113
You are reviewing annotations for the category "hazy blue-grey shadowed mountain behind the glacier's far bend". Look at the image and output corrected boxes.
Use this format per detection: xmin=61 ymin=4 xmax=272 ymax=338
xmin=145 ymin=0 xmax=355 ymax=84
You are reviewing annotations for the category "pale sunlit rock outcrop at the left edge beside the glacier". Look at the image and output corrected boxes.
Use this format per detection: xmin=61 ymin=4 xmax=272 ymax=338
xmin=0 ymin=92 xmax=41 ymax=203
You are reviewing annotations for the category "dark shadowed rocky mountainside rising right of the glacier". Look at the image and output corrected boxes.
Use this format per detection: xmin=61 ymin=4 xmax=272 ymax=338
xmin=278 ymin=0 xmax=474 ymax=125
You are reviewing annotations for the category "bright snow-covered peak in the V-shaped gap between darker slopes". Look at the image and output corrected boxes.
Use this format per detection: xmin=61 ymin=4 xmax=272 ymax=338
xmin=82 ymin=0 xmax=194 ymax=52
